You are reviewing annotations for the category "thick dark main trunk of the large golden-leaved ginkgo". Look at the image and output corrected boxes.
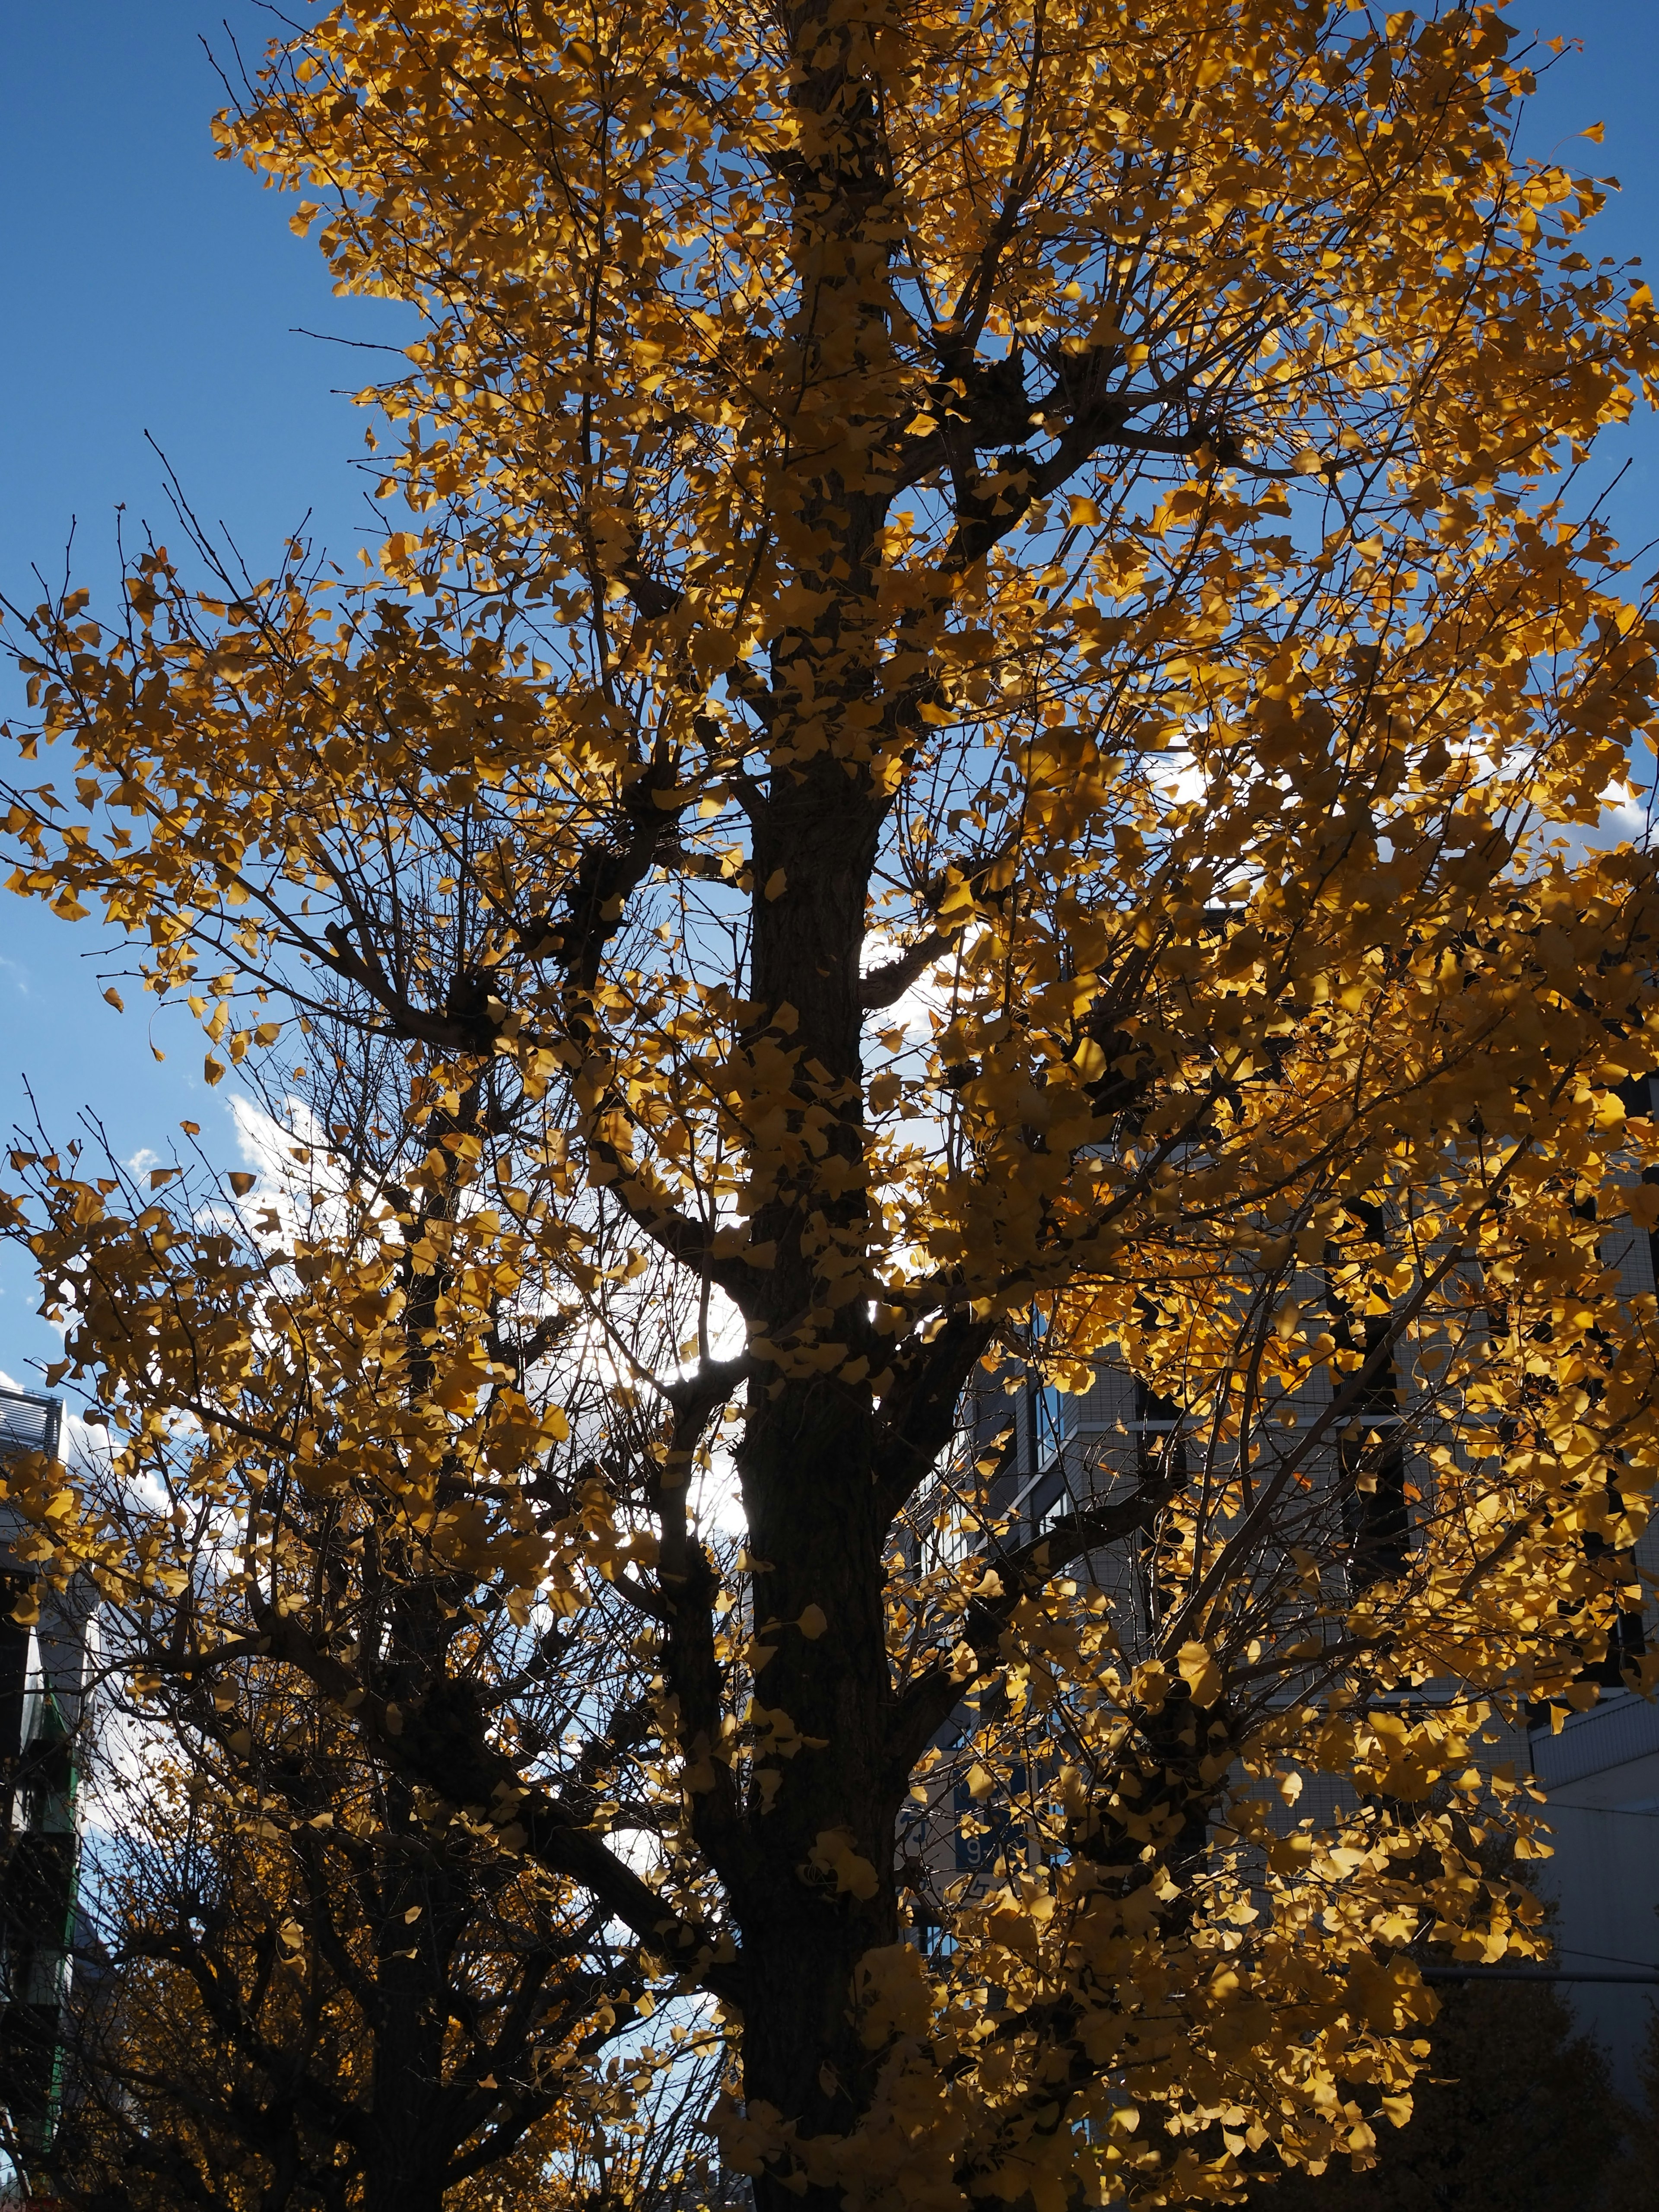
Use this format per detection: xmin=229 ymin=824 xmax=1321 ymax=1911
xmin=732 ymin=734 xmax=903 ymax=2212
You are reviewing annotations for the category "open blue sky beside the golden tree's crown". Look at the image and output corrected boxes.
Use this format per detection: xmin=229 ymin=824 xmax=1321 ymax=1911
xmin=0 ymin=0 xmax=1659 ymax=1376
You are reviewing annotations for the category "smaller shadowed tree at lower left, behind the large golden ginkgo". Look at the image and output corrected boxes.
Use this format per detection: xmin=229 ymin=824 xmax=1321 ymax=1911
xmin=51 ymin=1606 xmax=717 ymax=2212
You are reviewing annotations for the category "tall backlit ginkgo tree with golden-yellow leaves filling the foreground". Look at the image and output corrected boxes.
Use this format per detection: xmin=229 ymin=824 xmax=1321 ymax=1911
xmin=9 ymin=0 xmax=1659 ymax=2212
